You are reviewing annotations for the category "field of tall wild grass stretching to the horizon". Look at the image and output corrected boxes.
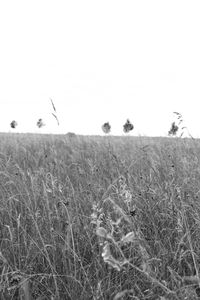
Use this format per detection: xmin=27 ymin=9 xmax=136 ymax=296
xmin=0 ymin=134 xmax=200 ymax=300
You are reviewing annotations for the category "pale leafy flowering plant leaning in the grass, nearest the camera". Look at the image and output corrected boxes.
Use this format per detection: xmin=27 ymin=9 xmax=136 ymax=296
xmin=91 ymin=177 xmax=175 ymax=300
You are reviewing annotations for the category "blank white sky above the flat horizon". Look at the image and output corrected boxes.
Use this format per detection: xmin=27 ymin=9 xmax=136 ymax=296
xmin=0 ymin=0 xmax=200 ymax=137
